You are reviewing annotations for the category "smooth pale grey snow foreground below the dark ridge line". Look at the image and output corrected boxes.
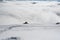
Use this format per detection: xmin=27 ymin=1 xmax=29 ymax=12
xmin=0 ymin=25 xmax=60 ymax=40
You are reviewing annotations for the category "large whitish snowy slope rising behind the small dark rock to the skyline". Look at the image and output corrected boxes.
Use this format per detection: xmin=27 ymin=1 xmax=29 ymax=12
xmin=0 ymin=2 xmax=60 ymax=25
